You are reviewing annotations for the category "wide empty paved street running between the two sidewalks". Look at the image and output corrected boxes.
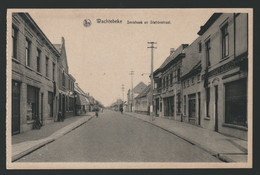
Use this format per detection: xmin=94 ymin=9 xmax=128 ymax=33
xmin=17 ymin=111 xmax=219 ymax=162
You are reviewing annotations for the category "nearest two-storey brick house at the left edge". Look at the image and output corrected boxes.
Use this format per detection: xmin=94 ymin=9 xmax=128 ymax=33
xmin=11 ymin=13 xmax=60 ymax=134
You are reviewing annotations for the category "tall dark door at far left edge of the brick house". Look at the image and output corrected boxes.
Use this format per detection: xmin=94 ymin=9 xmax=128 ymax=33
xmin=12 ymin=81 xmax=20 ymax=135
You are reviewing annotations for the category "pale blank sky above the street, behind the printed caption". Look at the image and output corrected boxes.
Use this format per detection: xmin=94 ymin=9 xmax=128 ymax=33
xmin=18 ymin=9 xmax=214 ymax=106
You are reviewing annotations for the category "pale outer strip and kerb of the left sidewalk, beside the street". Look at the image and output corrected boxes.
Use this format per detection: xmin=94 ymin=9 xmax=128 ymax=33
xmin=12 ymin=116 xmax=94 ymax=161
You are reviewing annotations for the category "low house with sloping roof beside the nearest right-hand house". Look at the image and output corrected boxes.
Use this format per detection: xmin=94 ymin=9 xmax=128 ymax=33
xmin=181 ymin=37 xmax=203 ymax=125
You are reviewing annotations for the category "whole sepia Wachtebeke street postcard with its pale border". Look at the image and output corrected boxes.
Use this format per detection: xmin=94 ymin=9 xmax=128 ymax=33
xmin=6 ymin=8 xmax=253 ymax=169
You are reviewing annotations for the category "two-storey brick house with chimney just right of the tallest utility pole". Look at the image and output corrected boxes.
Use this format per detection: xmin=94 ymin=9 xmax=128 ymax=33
xmin=153 ymin=44 xmax=188 ymax=120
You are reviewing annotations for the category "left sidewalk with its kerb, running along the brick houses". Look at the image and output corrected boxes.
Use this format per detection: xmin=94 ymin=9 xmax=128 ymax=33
xmin=12 ymin=112 xmax=94 ymax=161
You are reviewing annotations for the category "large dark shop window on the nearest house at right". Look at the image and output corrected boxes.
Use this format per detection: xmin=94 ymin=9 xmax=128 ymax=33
xmin=225 ymin=79 xmax=247 ymax=127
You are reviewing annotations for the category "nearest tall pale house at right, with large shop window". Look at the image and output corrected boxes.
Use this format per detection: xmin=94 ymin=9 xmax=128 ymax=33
xmin=198 ymin=13 xmax=248 ymax=140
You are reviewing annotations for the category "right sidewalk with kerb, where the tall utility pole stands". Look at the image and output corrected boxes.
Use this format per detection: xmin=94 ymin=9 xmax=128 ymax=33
xmin=125 ymin=112 xmax=247 ymax=162
